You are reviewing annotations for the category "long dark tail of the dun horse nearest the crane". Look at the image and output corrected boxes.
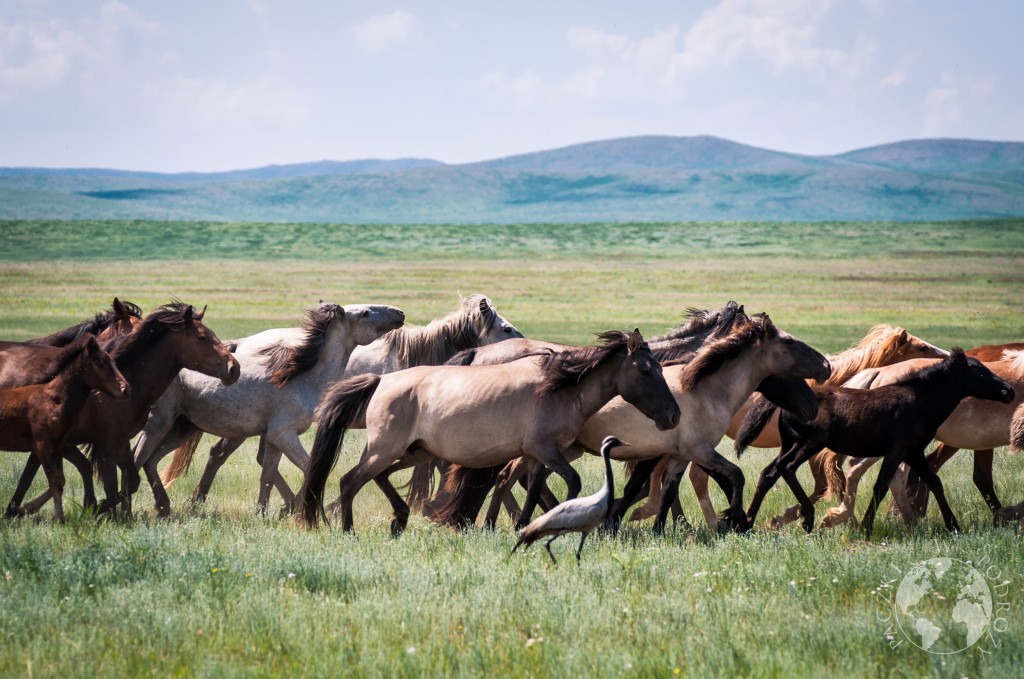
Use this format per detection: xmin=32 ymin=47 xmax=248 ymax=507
xmin=299 ymin=375 xmax=381 ymax=528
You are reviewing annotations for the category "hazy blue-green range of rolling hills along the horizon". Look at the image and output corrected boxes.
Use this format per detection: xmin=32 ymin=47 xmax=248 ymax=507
xmin=0 ymin=136 xmax=1024 ymax=223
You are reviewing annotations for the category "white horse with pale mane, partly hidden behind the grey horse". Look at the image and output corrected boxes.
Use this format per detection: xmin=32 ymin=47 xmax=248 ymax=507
xmin=163 ymin=294 xmax=522 ymax=508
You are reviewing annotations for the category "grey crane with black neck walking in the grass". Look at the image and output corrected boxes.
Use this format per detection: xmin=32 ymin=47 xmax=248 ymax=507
xmin=512 ymin=436 xmax=629 ymax=565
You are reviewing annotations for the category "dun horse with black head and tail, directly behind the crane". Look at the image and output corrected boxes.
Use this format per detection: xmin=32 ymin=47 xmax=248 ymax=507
xmin=301 ymin=330 xmax=679 ymax=533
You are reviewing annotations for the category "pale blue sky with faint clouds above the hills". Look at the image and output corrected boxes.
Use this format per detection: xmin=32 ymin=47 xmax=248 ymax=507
xmin=0 ymin=0 xmax=1024 ymax=171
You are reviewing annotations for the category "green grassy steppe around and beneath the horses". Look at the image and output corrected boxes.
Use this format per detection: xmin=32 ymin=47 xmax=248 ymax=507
xmin=0 ymin=221 xmax=1024 ymax=677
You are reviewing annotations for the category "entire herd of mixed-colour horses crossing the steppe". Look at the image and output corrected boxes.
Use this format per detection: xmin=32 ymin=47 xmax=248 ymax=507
xmin=0 ymin=295 xmax=1024 ymax=548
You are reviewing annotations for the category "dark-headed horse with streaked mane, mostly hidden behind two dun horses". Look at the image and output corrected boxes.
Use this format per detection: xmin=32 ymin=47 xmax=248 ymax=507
xmin=414 ymin=301 xmax=817 ymax=528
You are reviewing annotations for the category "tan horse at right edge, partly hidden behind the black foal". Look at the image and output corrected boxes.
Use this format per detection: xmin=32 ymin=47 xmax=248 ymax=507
xmin=821 ymin=351 xmax=1024 ymax=526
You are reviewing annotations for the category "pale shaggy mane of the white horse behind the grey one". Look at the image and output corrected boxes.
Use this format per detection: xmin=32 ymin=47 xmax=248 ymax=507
xmin=382 ymin=295 xmax=498 ymax=370
